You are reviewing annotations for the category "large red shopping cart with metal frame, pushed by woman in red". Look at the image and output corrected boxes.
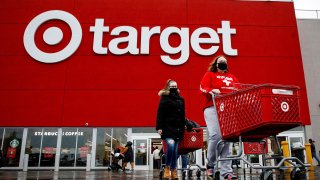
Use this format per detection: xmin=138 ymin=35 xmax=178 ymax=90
xmin=213 ymin=84 xmax=309 ymax=179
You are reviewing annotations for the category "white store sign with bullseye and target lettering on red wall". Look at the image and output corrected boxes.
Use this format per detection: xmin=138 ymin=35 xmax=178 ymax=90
xmin=23 ymin=10 xmax=238 ymax=65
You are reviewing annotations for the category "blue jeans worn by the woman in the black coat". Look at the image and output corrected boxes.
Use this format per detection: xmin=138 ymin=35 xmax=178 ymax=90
xmin=165 ymin=138 xmax=179 ymax=169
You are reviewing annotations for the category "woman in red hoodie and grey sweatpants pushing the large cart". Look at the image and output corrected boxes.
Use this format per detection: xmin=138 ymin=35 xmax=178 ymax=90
xmin=200 ymin=56 xmax=238 ymax=179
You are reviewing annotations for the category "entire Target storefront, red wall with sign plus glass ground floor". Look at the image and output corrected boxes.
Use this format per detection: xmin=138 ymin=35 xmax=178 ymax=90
xmin=0 ymin=0 xmax=310 ymax=170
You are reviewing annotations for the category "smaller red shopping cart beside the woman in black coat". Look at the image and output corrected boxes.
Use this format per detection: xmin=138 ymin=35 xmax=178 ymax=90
xmin=159 ymin=128 xmax=206 ymax=179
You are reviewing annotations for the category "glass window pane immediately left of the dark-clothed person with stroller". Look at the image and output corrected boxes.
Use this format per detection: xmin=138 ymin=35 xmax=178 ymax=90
xmin=95 ymin=128 xmax=112 ymax=167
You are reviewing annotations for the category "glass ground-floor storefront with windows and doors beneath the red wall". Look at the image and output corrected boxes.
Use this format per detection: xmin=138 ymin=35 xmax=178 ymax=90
xmin=0 ymin=128 xmax=305 ymax=170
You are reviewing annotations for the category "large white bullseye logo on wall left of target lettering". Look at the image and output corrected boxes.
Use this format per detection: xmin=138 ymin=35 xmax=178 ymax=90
xmin=23 ymin=10 xmax=82 ymax=63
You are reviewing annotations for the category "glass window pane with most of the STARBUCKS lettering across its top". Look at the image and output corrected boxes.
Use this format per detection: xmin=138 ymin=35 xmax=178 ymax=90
xmin=40 ymin=128 xmax=58 ymax=167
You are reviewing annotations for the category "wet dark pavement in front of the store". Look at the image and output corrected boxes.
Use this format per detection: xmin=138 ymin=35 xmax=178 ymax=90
xmin=0 ymin=166 xmax=320 ymax=180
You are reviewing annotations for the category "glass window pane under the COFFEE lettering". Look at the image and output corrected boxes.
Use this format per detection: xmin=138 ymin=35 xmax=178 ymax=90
xmin=60 ymin=128 xmax=78 ymax=167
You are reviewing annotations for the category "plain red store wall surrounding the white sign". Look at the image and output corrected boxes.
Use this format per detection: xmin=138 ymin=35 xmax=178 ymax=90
xmin=0 ymin=0 xmax=310 ymax=127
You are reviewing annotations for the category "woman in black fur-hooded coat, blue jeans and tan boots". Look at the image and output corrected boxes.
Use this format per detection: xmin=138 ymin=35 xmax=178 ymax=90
xmin=156 ymin=79 xmax=185 ymax=179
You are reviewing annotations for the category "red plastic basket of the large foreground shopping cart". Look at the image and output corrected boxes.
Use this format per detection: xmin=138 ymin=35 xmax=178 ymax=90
xmin=215 ymin=84 xmax=302 ymax=140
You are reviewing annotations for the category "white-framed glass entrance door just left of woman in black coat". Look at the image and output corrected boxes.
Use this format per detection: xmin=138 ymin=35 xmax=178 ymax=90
xmin=133 ymin=138 xmax=150 ymax=170
